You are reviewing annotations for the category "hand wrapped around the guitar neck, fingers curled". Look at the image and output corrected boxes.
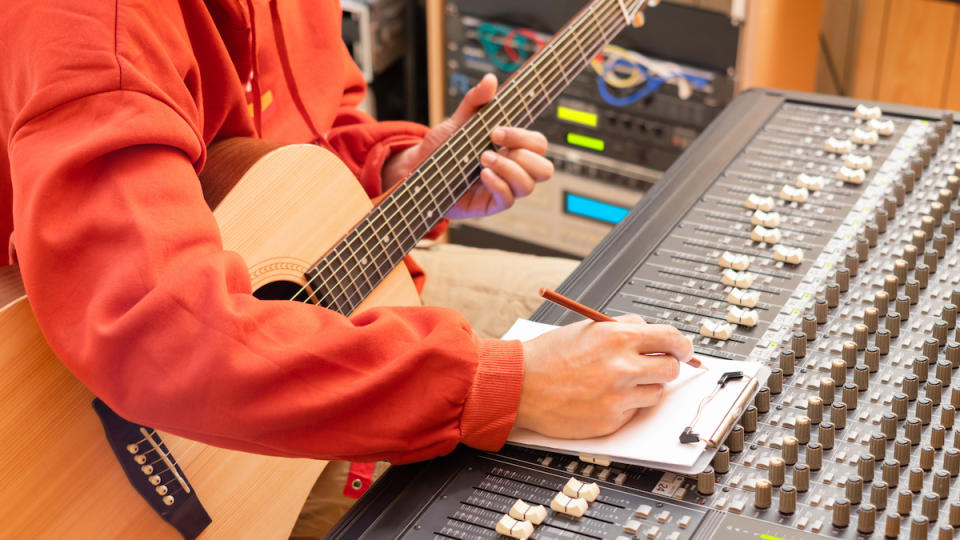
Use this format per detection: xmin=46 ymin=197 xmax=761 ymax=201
xmin=382 ymin=74 xmax=553 ymax=219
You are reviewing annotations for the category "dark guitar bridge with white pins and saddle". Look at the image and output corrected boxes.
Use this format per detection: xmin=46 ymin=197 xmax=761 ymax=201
xmin=93 ymin=399 xmax=211 ymax=540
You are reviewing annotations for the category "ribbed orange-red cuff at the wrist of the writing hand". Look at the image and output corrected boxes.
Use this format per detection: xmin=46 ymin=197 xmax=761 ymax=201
xmin=460 ymin=339 xmax=523 ymax=450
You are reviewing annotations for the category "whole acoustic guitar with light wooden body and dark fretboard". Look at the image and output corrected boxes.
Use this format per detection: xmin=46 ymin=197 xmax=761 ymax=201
xmin=0 ymin=0 xmax=646 ymax=539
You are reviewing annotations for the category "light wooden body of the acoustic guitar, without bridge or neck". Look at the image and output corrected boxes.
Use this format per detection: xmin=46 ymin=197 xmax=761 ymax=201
xmin=0 ymin=139 xmax=419 ymax=539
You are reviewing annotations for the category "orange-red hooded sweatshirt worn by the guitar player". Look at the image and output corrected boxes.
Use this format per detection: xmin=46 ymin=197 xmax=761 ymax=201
xmin=0 ymin=0 xmax=523 ymax=462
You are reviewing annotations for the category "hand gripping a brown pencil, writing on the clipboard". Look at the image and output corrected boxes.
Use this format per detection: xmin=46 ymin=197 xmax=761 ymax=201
xmin=515 ymin=315 xmax=693 ymax=439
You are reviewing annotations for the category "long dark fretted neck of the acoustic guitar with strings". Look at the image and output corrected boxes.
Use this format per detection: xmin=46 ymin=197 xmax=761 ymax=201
xmin=308 ymin=0 xmax=646 ymax=315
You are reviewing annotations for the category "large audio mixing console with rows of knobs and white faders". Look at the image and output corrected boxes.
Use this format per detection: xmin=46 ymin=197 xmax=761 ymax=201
xmin=333 ymin=90 xmax=960 ymax=540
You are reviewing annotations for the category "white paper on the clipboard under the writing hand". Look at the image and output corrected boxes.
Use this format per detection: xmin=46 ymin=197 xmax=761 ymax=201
xmin=503 ymin=319 xmax=767 ymax=474
